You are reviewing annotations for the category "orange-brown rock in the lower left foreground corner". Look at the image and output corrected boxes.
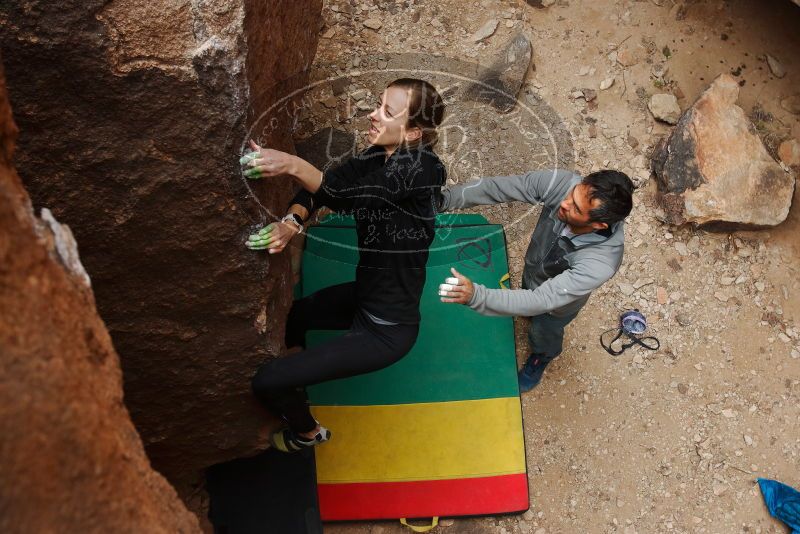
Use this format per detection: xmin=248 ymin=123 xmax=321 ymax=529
xmin=0 ymin=56 xmax=200 ymax=534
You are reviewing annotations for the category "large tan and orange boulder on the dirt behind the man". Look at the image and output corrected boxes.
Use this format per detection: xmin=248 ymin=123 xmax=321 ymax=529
xmin=652 ymin=74 xmax=795 ymax=230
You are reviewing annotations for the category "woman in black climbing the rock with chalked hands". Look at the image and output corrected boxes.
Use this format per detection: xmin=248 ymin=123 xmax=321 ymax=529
xmin=243 ymin=78 xmax=446 ymax=452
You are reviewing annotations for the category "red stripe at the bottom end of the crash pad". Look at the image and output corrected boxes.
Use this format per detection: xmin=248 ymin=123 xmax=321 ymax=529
xmin=317 ymin=473 xmax=528 ymax=521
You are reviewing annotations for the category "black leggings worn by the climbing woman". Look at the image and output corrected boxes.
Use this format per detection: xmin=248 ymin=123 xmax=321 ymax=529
xmin=252 ymin=282 xmax=419 ymax=432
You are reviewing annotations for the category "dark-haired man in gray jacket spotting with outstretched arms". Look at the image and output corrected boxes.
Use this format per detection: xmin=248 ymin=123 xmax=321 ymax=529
xmin=440 ymin=169 xmax=633 ymax=392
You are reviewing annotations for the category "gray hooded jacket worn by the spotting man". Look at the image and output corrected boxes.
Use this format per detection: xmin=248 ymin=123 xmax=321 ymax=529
xmin=441 ymin=169 xmax=625 ymax=317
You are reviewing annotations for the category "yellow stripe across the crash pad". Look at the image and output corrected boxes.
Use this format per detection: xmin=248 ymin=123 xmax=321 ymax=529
xmin=312 ymin=397 xmax=525 ymax=484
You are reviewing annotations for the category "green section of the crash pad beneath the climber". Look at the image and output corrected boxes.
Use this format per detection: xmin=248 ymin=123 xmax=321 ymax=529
xmin=301 ymin=215 xmax=519 ymax=406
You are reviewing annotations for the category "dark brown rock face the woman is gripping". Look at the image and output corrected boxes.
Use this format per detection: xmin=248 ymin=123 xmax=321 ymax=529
xmin=0 ymin=0 xmax=322 ymax=481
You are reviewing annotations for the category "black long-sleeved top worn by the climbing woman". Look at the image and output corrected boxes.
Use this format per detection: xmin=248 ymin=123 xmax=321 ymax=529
xmin=292 ymin=146 xmax=446 ymax=324
